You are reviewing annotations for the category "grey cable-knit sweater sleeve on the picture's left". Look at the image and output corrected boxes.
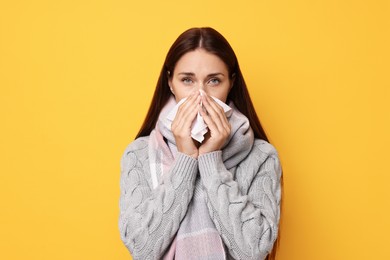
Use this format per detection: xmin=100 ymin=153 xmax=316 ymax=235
xmin=119 ymin=139 xmax=198 ymax=259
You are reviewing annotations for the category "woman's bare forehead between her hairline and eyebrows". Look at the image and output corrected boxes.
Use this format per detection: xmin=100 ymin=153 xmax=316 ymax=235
xmin=174 ymin=49 xmax=228 ymax=74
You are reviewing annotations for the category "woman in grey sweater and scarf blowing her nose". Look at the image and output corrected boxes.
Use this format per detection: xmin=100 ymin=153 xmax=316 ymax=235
xmin=119 ymin=28 xmax=281 ymax=260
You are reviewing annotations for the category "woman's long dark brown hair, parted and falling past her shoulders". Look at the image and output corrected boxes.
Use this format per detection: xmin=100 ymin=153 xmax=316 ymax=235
xmin=136 ymin=27 xmax=278 ymax=260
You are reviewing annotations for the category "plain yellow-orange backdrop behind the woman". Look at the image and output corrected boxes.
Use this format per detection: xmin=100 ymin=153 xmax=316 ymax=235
xmin=0 ymin=0 xmax=390 ymax=260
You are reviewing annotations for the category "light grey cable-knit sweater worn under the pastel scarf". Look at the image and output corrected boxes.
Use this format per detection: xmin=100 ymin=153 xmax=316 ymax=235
xmin=119 ymin=137 xmax=281 ymax=259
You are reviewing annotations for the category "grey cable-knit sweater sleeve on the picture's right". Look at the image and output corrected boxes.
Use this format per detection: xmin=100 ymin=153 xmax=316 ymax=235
xmin=198 ymin=142 xmax=281 ymax=259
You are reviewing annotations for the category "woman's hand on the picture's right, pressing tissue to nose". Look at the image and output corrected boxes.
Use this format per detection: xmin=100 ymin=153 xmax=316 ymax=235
xmin=199 ymin=92 xmax=231 ymax=155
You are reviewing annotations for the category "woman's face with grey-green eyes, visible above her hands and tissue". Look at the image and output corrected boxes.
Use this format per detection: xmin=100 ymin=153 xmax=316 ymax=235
xmin=169 ymin=49 xmax=232 ymax=103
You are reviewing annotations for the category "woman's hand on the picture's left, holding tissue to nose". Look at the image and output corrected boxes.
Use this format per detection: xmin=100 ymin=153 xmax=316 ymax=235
xmin=171 ymin=91 xmax=200 ymax=158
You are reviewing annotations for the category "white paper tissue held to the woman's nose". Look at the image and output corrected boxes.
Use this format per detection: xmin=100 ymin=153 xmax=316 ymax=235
xmin=167 ymin=92 xmax=232 ymax=143
